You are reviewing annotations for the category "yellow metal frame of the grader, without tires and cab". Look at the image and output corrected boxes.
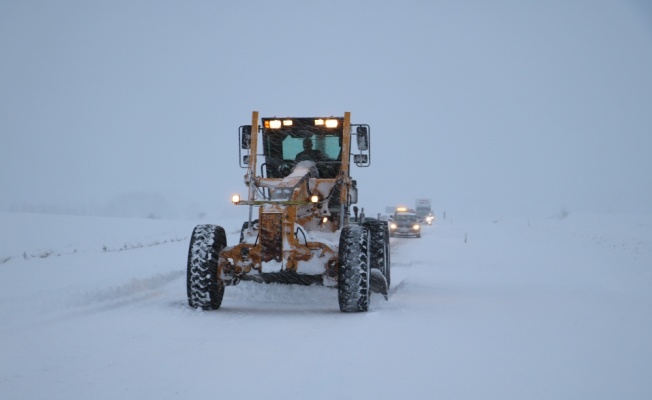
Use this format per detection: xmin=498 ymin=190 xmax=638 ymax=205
xmin=218 ymin=111 xmax=362 ymax=285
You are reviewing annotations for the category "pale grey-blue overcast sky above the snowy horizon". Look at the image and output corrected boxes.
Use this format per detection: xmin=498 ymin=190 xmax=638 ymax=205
xmin=0 ymin=0 xmax=652 ymax=219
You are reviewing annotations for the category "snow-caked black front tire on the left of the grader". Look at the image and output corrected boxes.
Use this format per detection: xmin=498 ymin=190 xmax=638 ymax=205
xmin=187 ymin=225 xmax=226 ymax=310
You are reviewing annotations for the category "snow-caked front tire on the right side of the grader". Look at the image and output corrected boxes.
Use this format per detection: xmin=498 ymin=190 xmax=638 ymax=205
xmin=337 ymin=225 xmax=371 ymax=312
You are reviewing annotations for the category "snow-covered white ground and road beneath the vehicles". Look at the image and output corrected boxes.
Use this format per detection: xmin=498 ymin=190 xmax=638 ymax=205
xmin=0 ymin=213 xmax=652 ymax=400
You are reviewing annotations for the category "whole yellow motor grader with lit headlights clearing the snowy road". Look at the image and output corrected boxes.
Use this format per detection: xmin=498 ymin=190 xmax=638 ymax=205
xmin=187 ymin=111 xmax=390 ymax=312
